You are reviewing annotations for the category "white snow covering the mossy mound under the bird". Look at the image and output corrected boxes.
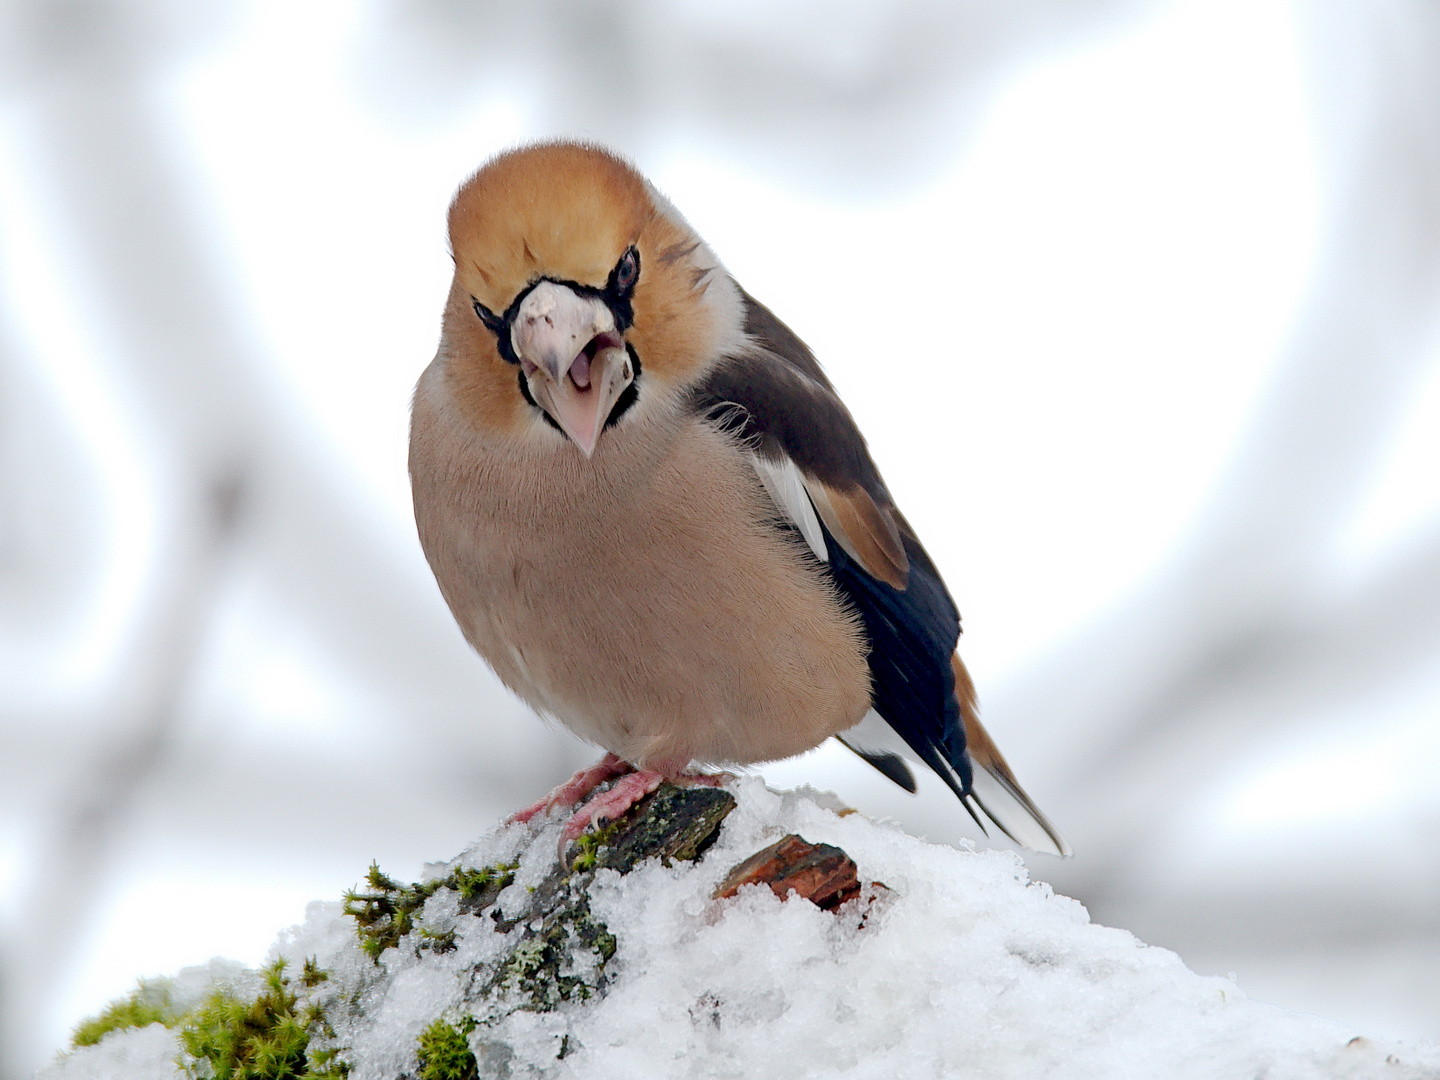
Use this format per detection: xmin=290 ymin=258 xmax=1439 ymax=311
xmin=39 ymin=779 xmax=1440 ymax=1080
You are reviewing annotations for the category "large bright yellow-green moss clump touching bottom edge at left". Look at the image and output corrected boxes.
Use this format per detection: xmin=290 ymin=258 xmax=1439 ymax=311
xmin=179 ymin=960 xmax=350 ymax=1080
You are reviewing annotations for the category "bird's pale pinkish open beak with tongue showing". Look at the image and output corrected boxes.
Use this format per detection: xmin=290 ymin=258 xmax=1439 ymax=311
xmin=510 ymin=281 xmax=635 ymax=458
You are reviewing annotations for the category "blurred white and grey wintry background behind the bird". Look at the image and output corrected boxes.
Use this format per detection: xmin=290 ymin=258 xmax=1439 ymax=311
xmin=0 ymin=0 xmax=1440 ymax=1079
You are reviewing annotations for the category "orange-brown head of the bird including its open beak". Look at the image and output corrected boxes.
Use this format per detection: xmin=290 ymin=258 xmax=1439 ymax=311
xmin=442 ymin=143 xmax=739 ymax=458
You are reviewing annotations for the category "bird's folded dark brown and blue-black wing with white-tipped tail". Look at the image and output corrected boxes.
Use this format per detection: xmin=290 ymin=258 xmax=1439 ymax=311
xmin=693 ymin=283 xmax=1068 ymax=852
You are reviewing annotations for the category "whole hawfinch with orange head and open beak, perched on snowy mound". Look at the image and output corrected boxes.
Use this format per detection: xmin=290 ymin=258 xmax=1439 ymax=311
xmin=410 ymin=143 xmax=1070 ymax=854
